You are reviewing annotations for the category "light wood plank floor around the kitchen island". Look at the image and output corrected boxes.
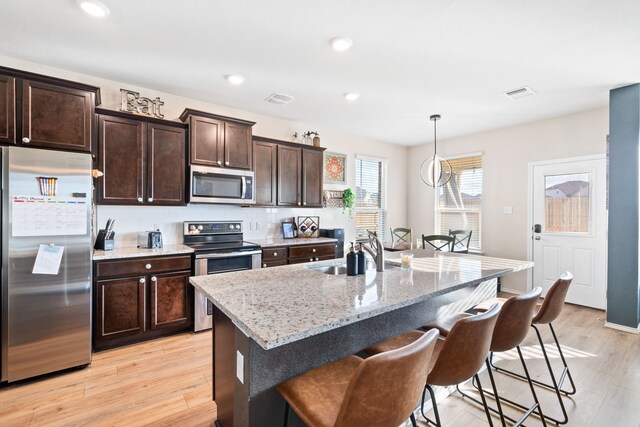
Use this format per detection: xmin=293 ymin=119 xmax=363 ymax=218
xmin=0 ymin=305 xmax=640 ymax=427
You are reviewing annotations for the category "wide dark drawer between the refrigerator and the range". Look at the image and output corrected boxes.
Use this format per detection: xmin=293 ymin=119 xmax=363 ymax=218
xmin=96 ymin=255 xmax=191 ymax=277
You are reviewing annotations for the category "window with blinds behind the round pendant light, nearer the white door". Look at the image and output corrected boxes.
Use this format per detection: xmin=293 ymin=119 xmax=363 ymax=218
xmin=435 ymin=155 xmax=482 ymax=250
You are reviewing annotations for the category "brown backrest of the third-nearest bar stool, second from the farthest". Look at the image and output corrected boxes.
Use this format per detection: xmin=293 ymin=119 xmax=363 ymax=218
xmin=490 ymin=287 xmax=542 ymax=351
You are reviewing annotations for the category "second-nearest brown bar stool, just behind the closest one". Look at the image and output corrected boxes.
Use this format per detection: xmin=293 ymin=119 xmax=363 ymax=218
xmin=364 ymin=304 xmax=500 ymax=426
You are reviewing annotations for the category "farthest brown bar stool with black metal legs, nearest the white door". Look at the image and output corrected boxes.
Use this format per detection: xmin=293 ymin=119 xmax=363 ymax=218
xmin=476 ymin=272 xmax=576 ymax=424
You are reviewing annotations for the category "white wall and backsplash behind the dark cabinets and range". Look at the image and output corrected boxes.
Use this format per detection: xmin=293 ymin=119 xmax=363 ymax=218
xmin=0 ymin=56 xmax=408 ymax=246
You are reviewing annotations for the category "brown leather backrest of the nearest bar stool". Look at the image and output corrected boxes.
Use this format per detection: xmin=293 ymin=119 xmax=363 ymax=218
xmin=335 ymin=331 xmax=438 ymax=427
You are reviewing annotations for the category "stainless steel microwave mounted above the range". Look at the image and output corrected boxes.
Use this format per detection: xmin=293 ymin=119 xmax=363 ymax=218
xmin=189 ymin=166 xmax=256 ymax=205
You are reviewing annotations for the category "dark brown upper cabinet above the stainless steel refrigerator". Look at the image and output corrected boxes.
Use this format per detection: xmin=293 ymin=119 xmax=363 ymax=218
xmin=0 ymin=67 xmax=100 ymax=152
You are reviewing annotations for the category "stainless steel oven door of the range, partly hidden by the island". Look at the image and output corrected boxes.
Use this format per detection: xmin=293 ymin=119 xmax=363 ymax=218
xmin=193 ymin=250 xmax=262 ymax=332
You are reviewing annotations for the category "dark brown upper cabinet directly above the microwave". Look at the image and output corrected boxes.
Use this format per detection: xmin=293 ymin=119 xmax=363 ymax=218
xmin=180 ymin=108 xmax=255 ymax=170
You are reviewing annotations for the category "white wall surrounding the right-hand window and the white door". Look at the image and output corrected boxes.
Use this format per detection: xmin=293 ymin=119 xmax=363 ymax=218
xmin=407 ymin=108 xmax=609 ymax=291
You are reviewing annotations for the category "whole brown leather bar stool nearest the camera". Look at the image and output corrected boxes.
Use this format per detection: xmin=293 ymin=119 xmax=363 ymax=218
xmin=277 ymin=331 xmax=438 ymax=427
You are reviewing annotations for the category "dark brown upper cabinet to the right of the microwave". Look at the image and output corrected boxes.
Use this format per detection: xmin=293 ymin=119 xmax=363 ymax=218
xmin=253 ymin=136 xmax=325 ymax=207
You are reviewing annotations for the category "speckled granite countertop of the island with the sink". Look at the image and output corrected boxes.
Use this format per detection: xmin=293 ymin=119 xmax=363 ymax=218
xmin=190 ymin=249 xmax=533 ymax=350
